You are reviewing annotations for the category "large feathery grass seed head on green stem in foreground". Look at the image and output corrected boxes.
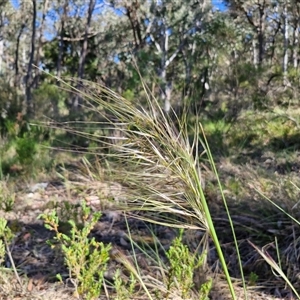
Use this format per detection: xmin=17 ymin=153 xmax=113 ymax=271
xmin=51 ymin=81 xmax=246 ymax=299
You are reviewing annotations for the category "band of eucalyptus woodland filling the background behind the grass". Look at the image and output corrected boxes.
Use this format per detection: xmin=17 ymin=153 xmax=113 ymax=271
xmin=0 ymin=0 xmax=299 ymax=118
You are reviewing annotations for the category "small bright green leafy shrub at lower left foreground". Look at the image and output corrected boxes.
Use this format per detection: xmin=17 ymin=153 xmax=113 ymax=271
xmin=40 ymin=202 xmax=111 ymax=299
